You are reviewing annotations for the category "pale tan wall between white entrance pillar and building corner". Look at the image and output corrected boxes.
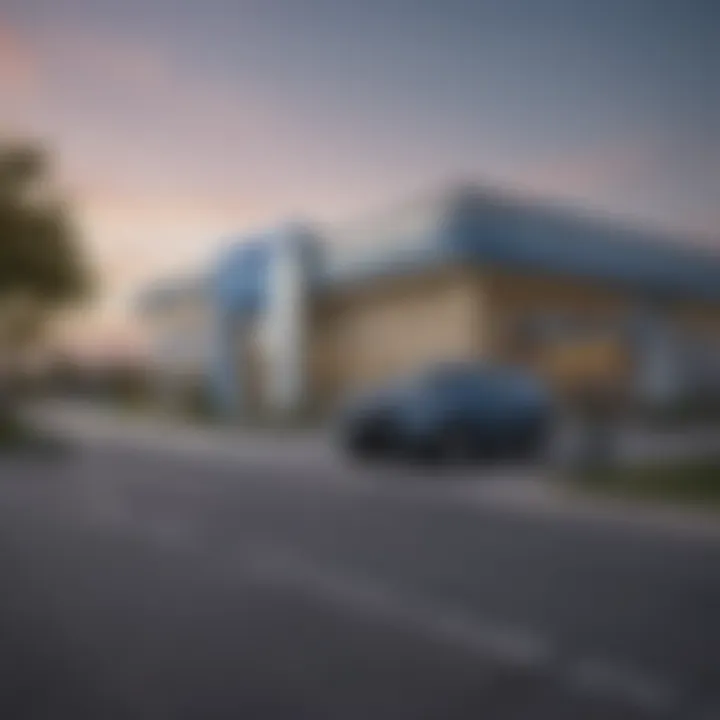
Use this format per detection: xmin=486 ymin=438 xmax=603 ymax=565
xmin=309 ymin=268 xmax=484 ymax=402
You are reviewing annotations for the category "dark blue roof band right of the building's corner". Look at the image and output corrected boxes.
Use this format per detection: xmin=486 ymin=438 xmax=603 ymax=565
xmin=445 ymin=190 xmax=720 ymax=301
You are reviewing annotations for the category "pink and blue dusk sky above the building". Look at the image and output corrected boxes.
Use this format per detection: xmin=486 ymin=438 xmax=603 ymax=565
xmin=0 ymin=0 xmax=720 ymax=354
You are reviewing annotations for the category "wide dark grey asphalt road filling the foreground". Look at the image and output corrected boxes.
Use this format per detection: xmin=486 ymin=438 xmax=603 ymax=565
xmin=0 ymin=430 xmax=720 ymax=720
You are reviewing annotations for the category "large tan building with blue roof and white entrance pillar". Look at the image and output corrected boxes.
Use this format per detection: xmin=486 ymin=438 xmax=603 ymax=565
xmin=137 ymin=188 xmax=720 ymax=414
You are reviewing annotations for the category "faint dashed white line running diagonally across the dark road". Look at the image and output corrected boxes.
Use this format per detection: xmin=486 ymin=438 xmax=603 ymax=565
xmin=32 ymin=484 xmax=688 ymax=720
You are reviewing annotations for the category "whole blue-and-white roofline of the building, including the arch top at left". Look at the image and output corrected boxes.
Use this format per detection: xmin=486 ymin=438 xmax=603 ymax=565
xmin=140 ymin=186 xmax=720 ymax=310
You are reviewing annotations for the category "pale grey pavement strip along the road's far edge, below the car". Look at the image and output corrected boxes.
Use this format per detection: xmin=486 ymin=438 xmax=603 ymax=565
xmin=46 ymin=408 xmax=720 ymax=544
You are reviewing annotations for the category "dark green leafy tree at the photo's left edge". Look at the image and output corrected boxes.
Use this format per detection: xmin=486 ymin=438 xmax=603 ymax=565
xmin=0 ymin=141 xmax=90 ymax=396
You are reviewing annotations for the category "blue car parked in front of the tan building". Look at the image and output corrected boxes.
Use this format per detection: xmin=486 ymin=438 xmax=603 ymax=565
xmin=337 ymin=363 xmax=553 ymax=460
